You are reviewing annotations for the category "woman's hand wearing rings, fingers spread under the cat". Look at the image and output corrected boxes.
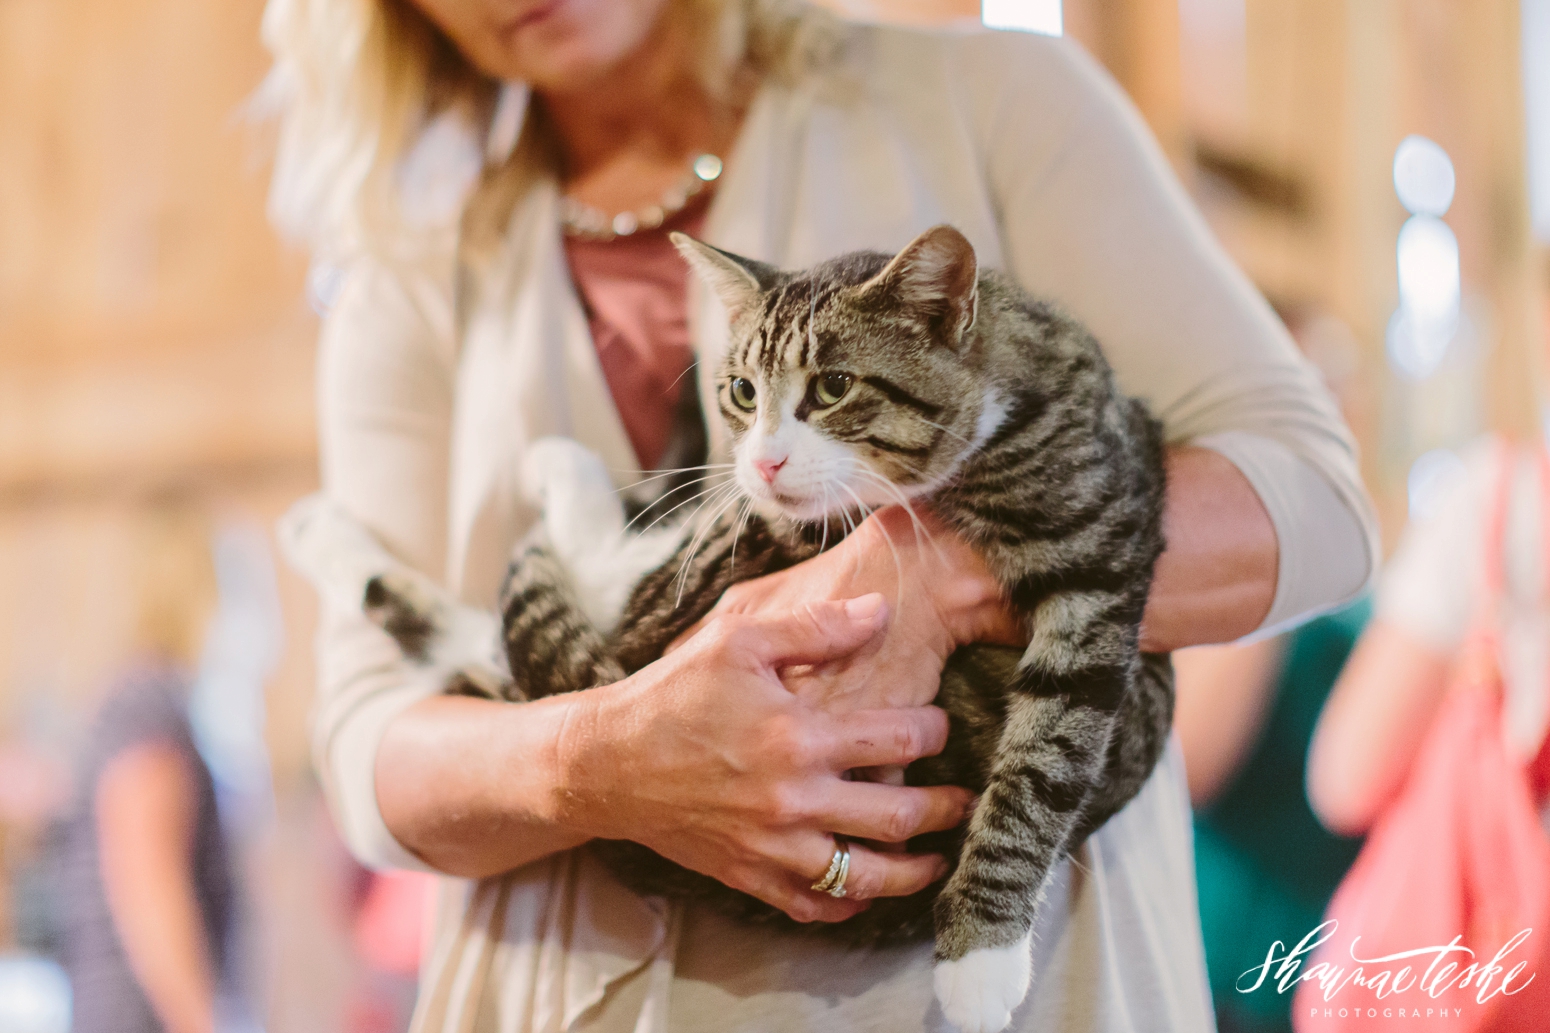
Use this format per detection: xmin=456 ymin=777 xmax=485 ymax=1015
xmin=556 ymin=596 xmax=970 ymax=921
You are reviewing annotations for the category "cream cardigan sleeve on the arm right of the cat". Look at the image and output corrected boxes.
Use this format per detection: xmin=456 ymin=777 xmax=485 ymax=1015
xmin=955 ymin=33 xmax=1380 ymax=631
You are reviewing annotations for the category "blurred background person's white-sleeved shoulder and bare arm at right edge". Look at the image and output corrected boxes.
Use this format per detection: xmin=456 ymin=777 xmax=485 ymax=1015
xmin=1308 ymin=424 xmax=1550 ymax=834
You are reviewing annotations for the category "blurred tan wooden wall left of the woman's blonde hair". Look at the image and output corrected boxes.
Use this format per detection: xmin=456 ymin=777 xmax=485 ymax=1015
xmin=0 ymin=0 xmax=316 ymax=779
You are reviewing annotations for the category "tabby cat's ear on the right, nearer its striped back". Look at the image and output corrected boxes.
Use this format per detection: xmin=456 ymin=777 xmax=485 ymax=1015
xmin=860 ymin=225 xmax=980 ymax=351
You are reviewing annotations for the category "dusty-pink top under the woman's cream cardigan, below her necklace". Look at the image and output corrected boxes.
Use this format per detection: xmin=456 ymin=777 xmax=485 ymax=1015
xmin=566 ymin=194 xmax=707 ymax=470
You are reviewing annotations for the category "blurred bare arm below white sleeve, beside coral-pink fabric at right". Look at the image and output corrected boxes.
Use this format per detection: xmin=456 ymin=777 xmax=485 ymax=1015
xmin=1308 ymin=617 xmax=1449 ymax=836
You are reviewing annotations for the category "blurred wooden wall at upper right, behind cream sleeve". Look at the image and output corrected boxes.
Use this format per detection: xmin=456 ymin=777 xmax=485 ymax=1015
xmin=1184 ymin=0 xmax=1547 ymax=541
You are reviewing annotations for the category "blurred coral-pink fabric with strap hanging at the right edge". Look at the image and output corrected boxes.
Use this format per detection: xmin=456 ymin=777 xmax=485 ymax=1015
xmin=1293 ymin=448 xmax=1550 ymax=1033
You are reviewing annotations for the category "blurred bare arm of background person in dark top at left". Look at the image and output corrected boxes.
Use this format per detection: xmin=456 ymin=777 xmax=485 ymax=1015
xmin=93 ymin=743 xmax=215 ymax=1033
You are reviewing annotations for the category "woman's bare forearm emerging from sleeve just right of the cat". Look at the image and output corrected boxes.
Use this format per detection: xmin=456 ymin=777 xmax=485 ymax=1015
xmin=1141 ymin=447 xmax=1280 ymax=653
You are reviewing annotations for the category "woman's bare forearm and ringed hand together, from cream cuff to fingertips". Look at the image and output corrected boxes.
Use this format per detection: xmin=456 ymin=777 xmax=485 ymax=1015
xmin=377 ymin=596 xmax=970 ymax=921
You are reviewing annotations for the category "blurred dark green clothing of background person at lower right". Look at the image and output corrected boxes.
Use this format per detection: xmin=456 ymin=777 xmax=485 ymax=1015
xmin=1195 ymin=599 xmax=1372 ymax=1033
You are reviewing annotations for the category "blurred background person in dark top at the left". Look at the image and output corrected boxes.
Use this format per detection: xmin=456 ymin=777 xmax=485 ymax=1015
xmin=54 ymin=495 xmax=236 ymax=1033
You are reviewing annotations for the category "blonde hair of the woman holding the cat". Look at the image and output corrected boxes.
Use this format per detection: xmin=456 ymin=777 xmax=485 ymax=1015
xmin=257 ymin=0 xmax=835 ymax=257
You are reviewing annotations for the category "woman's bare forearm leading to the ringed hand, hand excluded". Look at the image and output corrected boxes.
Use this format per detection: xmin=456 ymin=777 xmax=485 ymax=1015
xmin=377 ymin=689 xmax=592 ymax=878
